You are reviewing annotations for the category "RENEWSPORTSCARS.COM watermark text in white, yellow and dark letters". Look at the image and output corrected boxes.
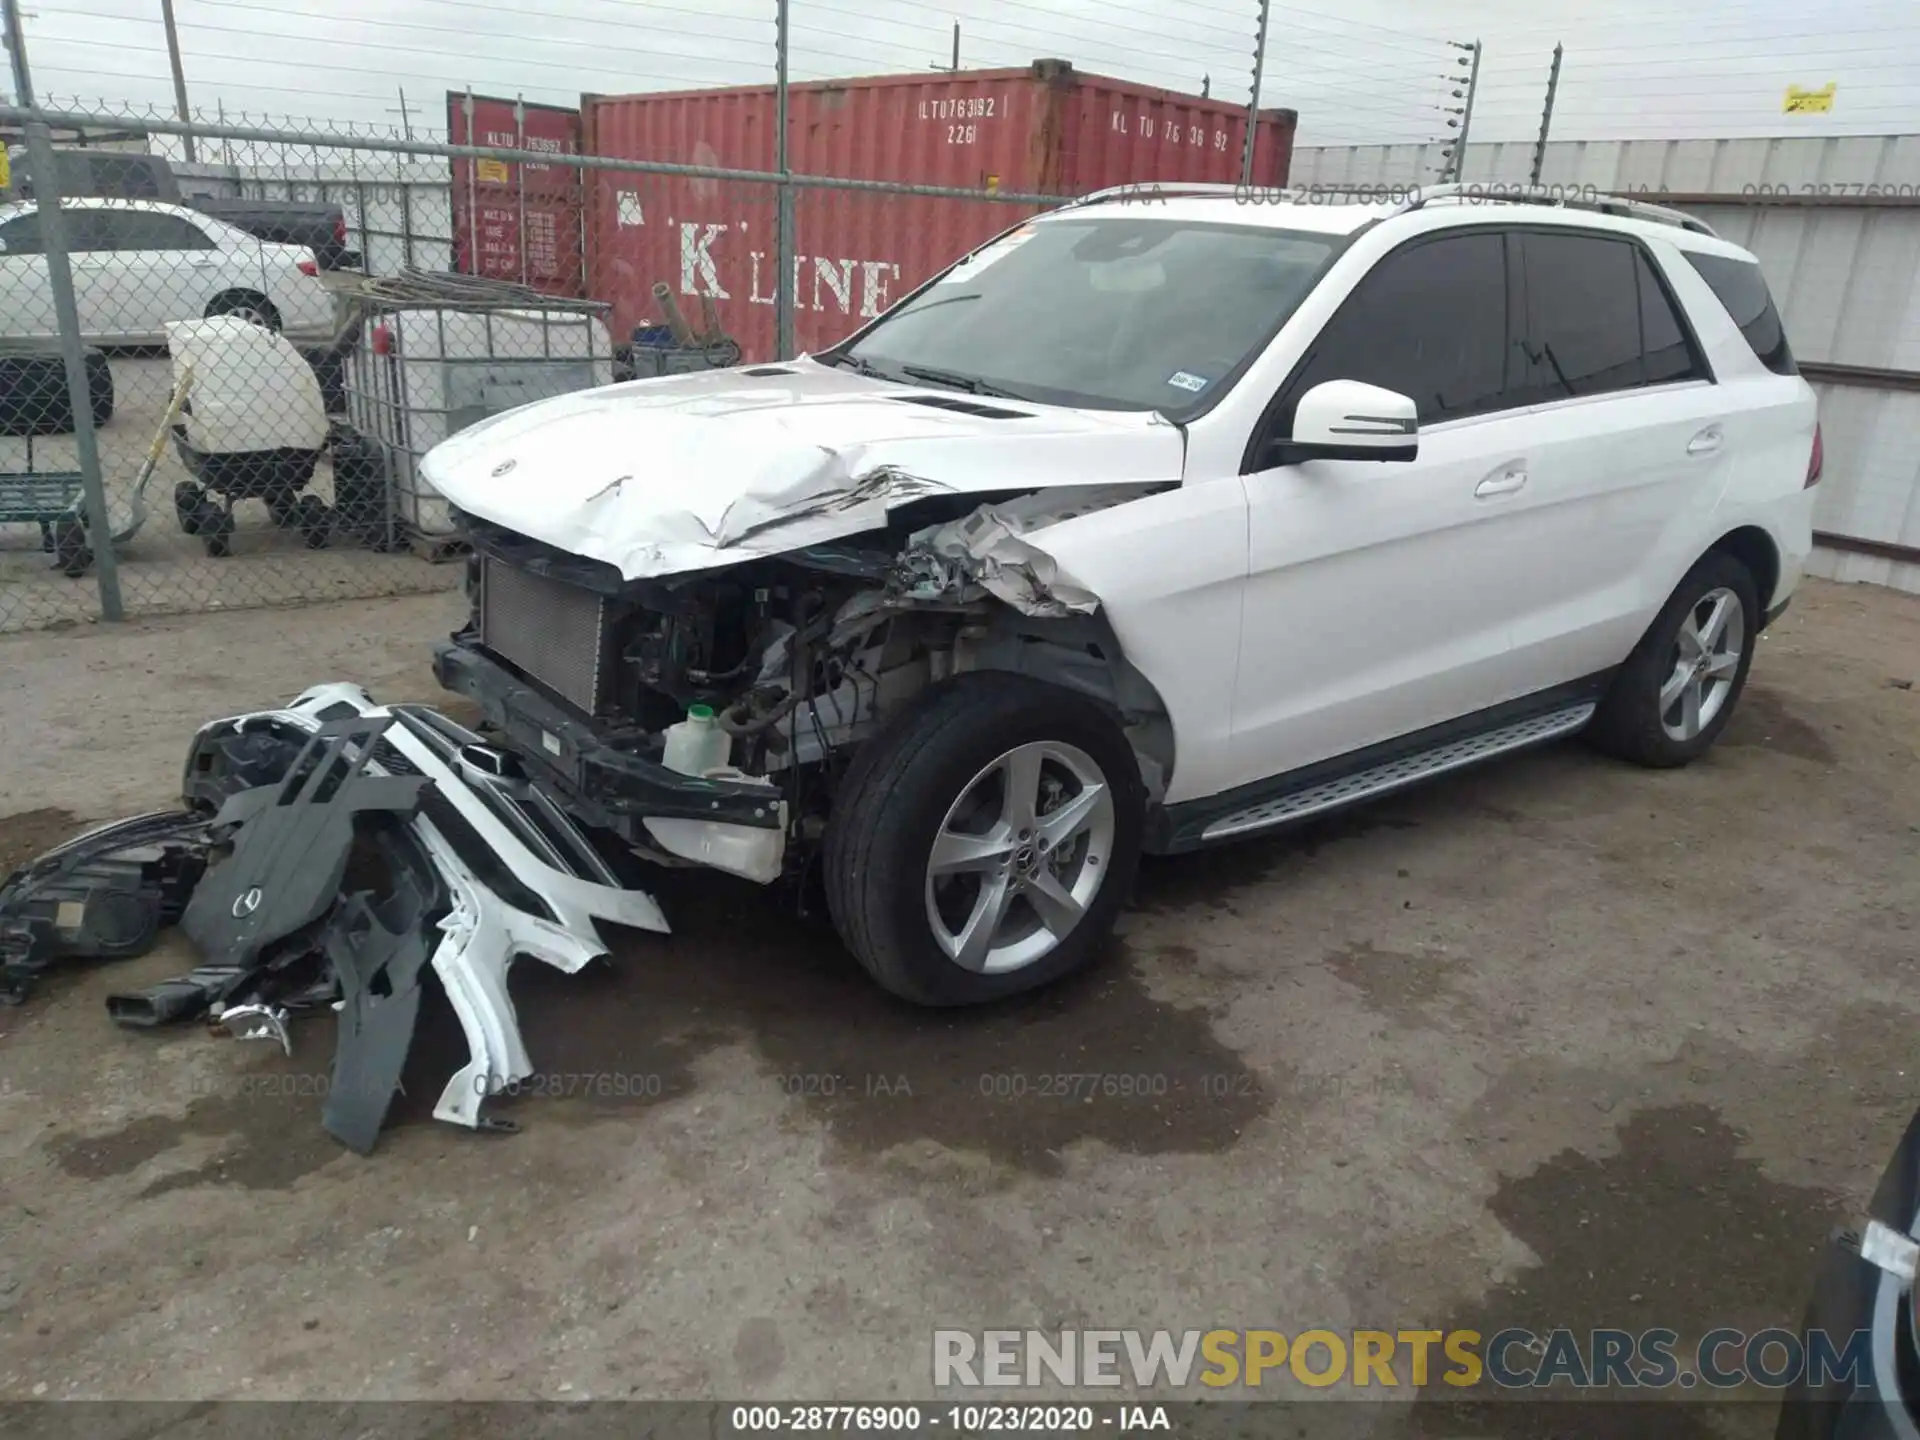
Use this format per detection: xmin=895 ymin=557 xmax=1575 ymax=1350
xmin=933 ymin=1327 xmax=1872 ymax=1390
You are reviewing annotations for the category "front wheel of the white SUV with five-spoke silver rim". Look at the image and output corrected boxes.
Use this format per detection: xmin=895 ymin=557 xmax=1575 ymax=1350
xmin=824 ymin=672 xmax=1146 ymax=1006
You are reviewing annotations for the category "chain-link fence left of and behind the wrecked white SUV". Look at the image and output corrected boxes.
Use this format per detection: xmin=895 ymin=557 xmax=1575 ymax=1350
xmin=0 ymin=96 xmax=1075 ymax=632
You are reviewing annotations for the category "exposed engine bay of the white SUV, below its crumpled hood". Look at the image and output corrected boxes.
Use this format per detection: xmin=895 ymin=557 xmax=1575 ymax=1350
xmin=440 ymin=486 xmax=1171 ymax=883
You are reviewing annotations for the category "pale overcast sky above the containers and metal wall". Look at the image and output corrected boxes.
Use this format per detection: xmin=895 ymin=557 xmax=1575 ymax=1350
xmin=21 ymin=0 xmax=1920 ymax=144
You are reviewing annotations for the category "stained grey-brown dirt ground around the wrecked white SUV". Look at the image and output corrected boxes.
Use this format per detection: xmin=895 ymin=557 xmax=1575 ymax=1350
xmin=0 ymin=582 xmax=1920 ymax=1436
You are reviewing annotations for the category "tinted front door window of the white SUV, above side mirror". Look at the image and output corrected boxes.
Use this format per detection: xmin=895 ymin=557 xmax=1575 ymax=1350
xmin=1275 ymin=232 xmax=1511 ymax=434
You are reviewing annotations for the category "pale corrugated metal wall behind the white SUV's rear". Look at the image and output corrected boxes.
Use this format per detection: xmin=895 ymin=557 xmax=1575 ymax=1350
xmin=1294 ymin=134 xmax=1920 ymax=593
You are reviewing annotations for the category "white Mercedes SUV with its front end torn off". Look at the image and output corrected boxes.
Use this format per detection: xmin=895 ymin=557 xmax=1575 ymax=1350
xmin=426 ymin=188 xmax=1820 ymax=1004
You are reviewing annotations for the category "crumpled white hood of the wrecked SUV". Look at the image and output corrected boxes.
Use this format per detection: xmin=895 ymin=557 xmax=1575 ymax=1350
xmin=420 ymin=361 xmax=1185 ymax=580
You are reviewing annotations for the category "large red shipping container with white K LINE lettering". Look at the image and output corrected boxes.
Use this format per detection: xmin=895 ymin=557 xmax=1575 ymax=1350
xmin=582 ymin=60 xmax=1296 ymax=361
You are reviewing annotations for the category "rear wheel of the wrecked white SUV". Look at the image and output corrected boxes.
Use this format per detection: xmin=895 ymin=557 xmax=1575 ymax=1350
xmin=1586 ymin=551 xmax=1761 ymax=770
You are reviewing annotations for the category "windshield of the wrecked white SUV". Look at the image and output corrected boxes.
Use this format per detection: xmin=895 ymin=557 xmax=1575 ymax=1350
xmin=840 ymin=215 xmax=1338 ymax=419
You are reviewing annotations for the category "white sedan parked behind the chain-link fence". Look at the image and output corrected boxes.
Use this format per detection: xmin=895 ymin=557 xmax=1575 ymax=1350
xmin=0 ymin=198 xmax=334 ymax=346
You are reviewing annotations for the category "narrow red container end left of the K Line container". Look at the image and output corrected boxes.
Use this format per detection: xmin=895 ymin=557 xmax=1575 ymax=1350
xmin=447 ymin=90 xmax=586 ymax=296
